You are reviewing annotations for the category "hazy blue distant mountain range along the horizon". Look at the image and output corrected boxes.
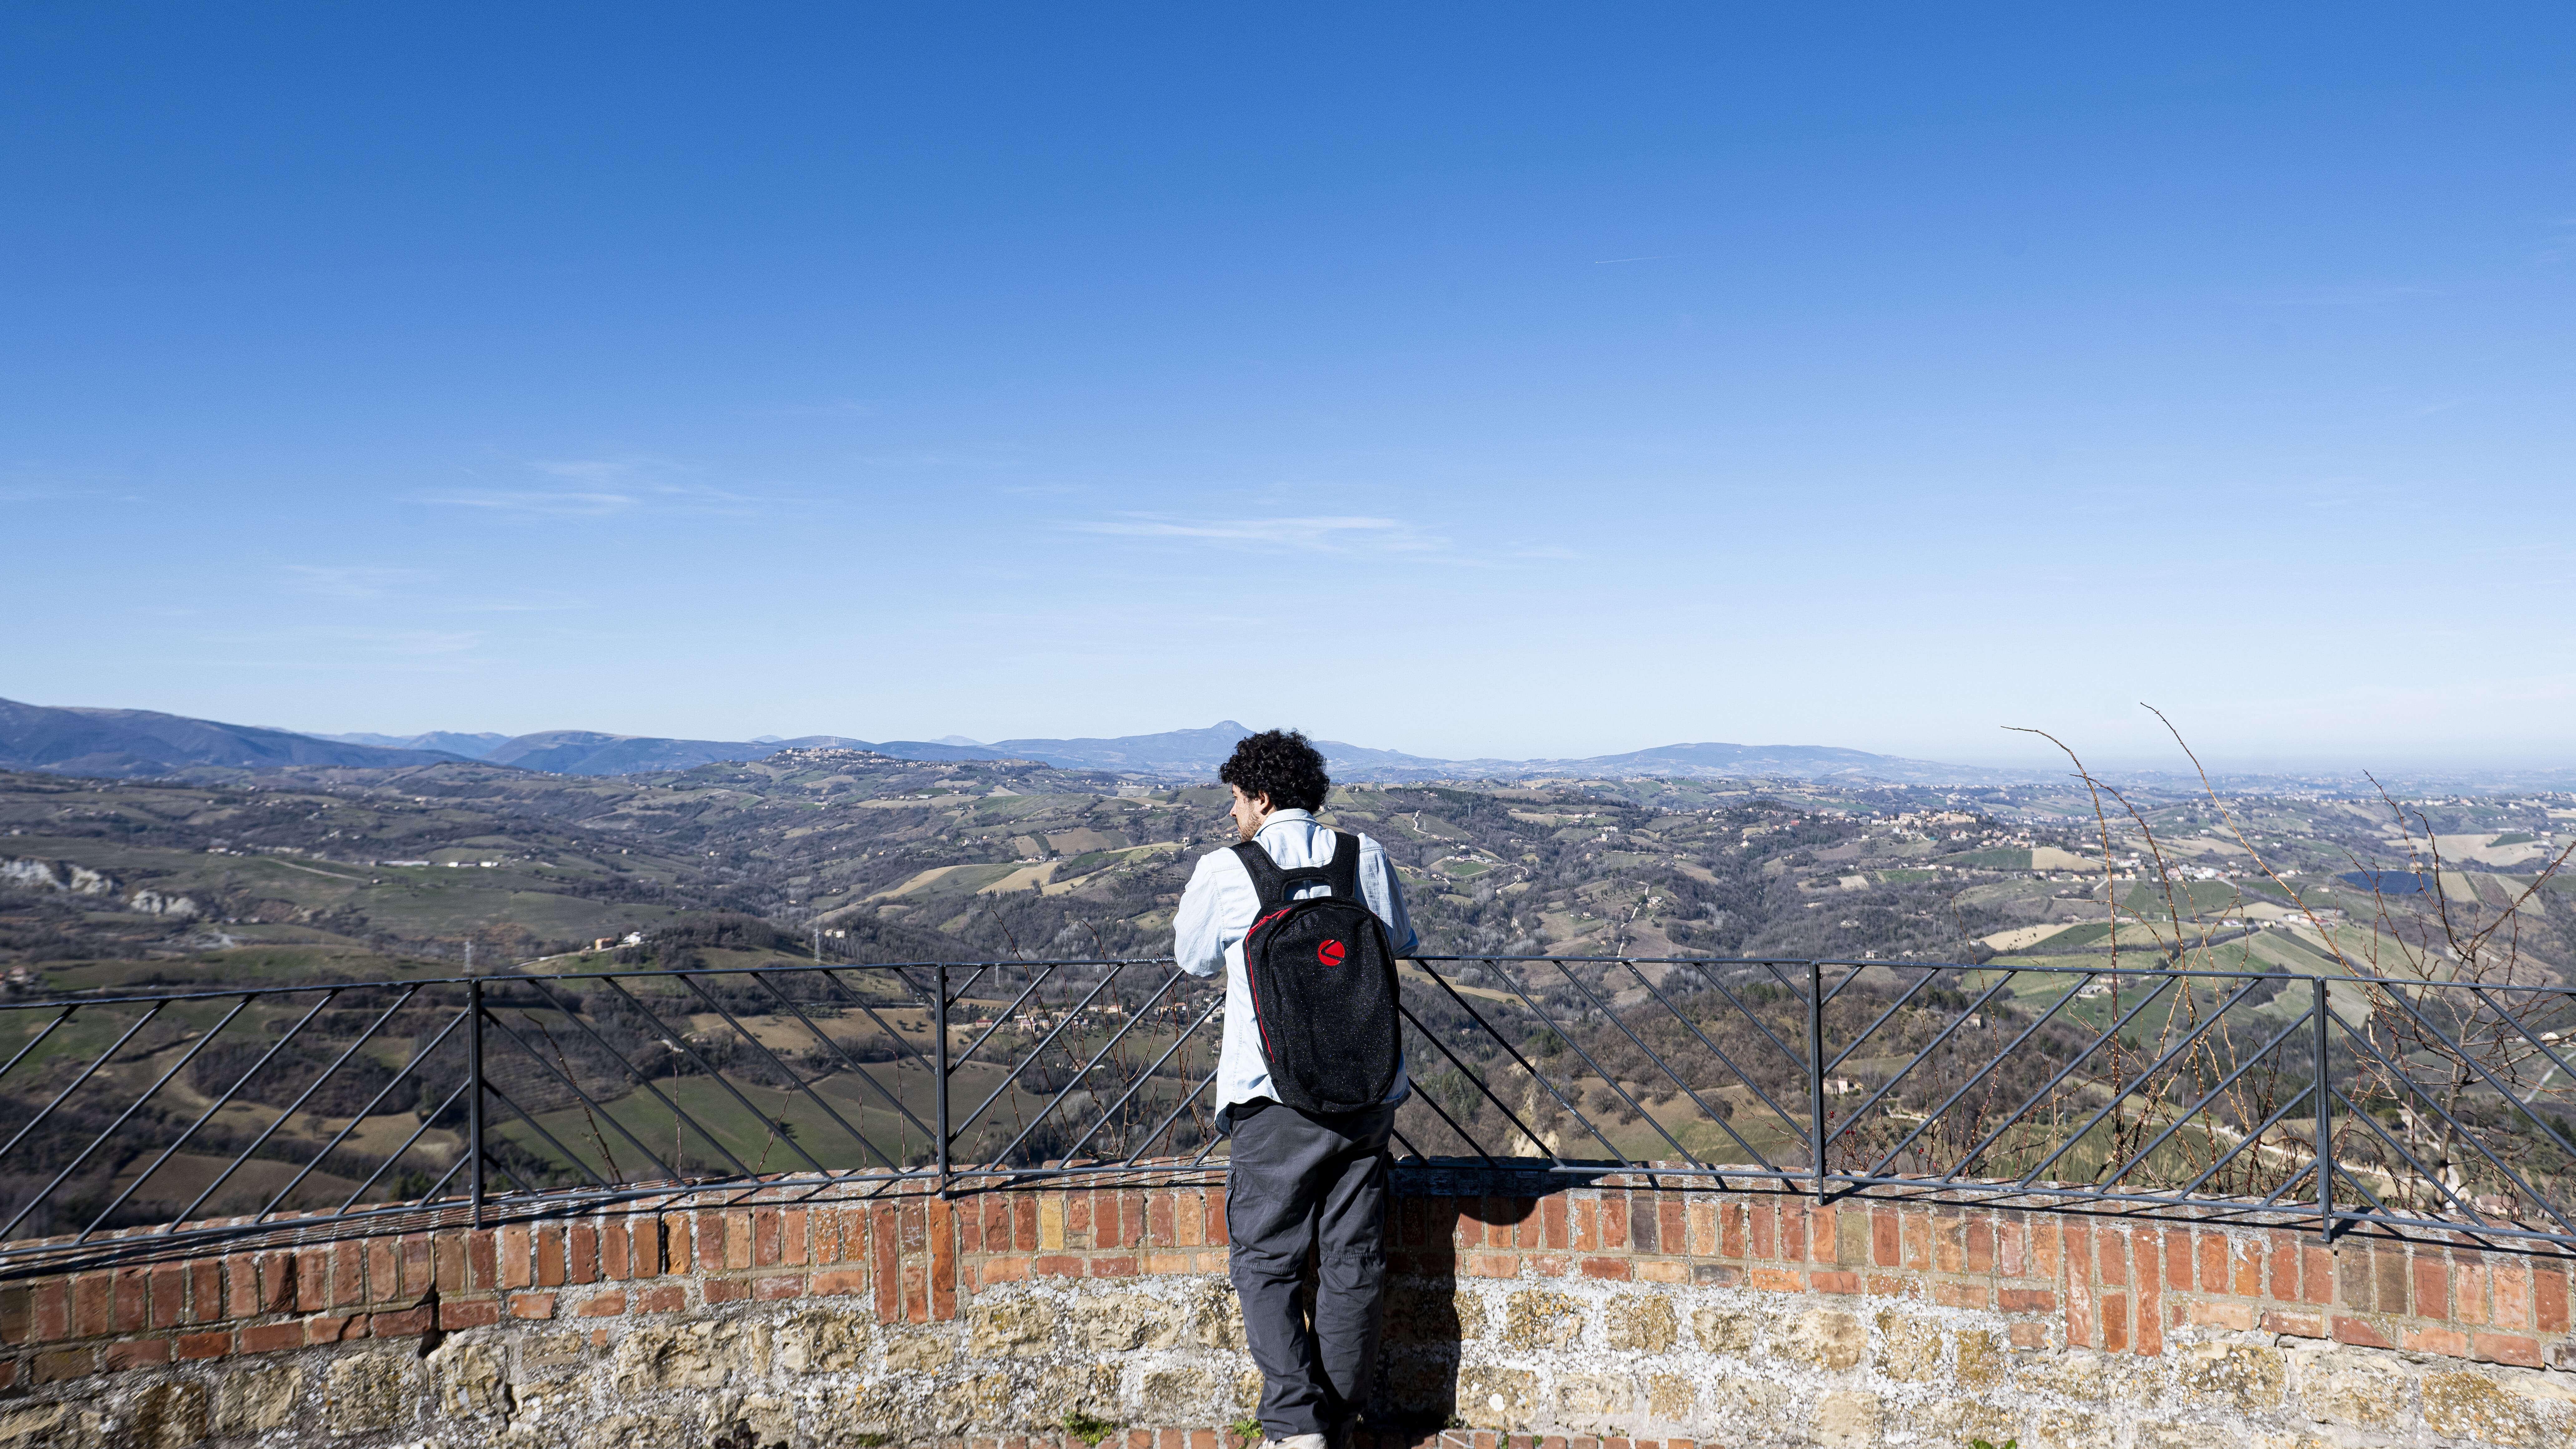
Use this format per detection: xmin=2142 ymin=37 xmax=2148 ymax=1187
xmin=0 ymin=699 xmax=2027 ymax=784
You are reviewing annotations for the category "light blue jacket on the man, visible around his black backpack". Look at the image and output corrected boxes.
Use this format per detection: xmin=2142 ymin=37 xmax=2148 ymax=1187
xmin=1172 ymin=810 xmax=1417 ymax=1111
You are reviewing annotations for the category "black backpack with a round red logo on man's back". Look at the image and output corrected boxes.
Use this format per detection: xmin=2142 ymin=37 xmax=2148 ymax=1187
xmin=1234 ymin=830 xmax=1404 ymax=1111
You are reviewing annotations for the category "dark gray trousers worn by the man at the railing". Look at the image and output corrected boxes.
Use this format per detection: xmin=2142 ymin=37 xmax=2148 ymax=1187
xmin=1226 ymin=1104 xmax=1396 ymax=1439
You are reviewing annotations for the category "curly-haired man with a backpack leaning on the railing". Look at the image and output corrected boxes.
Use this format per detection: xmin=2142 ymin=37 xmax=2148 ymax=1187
xmin=1172 ymin=730 xmax=1414 ymax=1449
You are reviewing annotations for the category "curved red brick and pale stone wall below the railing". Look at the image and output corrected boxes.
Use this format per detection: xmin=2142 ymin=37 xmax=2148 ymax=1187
xmin=0 ymin=1173 xmax=2576 ymax=1449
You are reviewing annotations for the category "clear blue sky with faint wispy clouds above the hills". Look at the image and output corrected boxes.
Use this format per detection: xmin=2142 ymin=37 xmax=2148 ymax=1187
xmin=0 ymin=5 xmax=2576 ymax=766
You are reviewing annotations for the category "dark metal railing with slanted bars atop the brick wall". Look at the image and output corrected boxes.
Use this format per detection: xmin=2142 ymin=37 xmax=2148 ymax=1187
xmin=0 ymin=957 xmax=2576 ymax=1276
